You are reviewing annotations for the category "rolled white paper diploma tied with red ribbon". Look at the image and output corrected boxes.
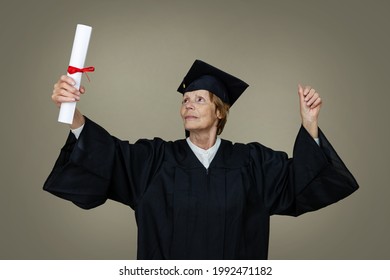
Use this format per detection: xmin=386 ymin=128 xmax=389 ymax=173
xmin=58 ymin=24 xmax=92 ymax=124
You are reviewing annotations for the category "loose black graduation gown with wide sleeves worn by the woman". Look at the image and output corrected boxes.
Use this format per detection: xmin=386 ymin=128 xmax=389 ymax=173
xmin=44 ymin=119 xmax=358 ymax=259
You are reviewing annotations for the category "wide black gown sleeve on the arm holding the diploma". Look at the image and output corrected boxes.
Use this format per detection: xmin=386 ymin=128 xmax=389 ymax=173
xmin=43 ymin=118 xmax=163 ymax=209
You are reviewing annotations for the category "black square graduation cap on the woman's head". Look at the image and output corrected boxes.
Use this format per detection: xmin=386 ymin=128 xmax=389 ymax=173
xmin=177 ymin=60 xmax=249 ymax=106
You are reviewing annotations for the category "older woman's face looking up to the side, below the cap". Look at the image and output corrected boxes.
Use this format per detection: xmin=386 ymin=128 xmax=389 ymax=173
xmin=180 ymin=90 xmax=220 ymax=135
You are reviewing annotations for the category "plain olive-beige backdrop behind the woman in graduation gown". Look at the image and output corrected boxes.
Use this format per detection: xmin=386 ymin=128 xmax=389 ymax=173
xmin=0 ymin=0 xmax=390 ymax=259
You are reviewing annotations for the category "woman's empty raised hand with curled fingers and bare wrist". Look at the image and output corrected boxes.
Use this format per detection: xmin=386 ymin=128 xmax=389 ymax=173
xmin=298 ymin=85 xmax=322 ymax=138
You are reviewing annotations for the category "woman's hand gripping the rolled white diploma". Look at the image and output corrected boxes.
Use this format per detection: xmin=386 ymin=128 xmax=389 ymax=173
xmin=51 ymin=75 xmax=85 ymax=107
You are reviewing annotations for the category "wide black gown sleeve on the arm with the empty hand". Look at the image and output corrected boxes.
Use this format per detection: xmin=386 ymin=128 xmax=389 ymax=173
xmin=251 ymin=126 xmax=359 ymax=216
